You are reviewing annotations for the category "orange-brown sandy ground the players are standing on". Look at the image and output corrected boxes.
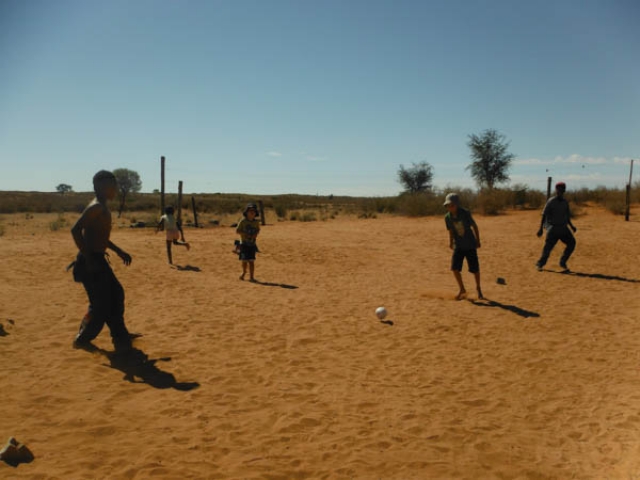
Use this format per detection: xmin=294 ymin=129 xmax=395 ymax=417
xmin=0 ymin=208 xmax=640 ymax=479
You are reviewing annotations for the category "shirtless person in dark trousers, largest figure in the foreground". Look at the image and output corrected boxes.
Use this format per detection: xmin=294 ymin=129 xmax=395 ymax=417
xmin=71 ymin=170 xmax=131 ymax=350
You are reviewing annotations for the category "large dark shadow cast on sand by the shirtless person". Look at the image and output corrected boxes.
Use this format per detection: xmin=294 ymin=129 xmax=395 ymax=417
xmin=83 ymin=344 xmax=200 ymax=392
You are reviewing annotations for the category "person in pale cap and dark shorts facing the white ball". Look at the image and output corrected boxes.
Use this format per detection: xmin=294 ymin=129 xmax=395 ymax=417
xmin=444 ymin=193 xmax=484 ymax=300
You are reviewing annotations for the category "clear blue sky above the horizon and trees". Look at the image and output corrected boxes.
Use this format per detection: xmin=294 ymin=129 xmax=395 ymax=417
xmin=0 ymin=0 xmax=640 ymax=196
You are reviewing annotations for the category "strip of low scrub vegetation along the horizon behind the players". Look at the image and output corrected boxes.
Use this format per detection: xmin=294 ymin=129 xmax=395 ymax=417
xmin=0 ymin=182 xmax=640 ymax=223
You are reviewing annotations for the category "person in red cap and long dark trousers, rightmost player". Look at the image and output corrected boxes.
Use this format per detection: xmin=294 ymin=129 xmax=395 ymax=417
xmin=536 ymin=182 xmax=578 ymax=272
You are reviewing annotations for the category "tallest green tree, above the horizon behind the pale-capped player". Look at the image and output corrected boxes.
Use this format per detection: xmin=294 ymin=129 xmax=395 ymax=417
xmin=466 ymin=129 xmax=516 ymax=190
